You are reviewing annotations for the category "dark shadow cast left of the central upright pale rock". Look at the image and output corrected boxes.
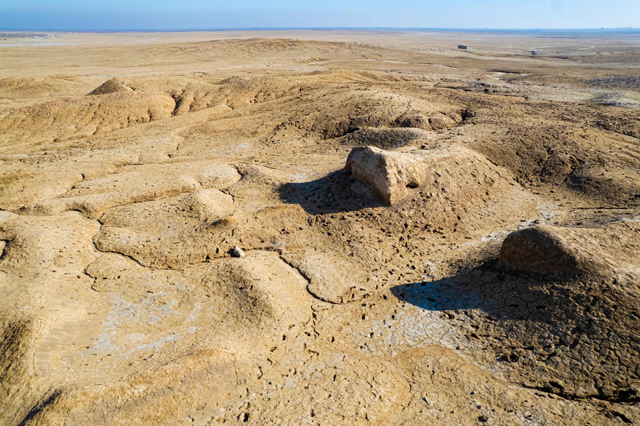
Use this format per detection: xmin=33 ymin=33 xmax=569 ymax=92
xmin=278 ymin=170 xmax=386 ymax=215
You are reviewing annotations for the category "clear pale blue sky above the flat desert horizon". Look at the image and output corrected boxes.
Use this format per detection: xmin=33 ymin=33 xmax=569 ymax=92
xmin=0 ymin=0 xmax=640 ymax=30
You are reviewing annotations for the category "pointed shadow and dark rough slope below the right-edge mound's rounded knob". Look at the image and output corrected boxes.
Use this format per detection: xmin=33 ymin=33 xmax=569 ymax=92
xmin=391 ymin=259 xmax=640 ymax=402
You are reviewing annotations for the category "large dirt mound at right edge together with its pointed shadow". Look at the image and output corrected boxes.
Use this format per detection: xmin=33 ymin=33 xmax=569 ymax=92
xmin=394 ymin=220 xmax=640 ymax=402
